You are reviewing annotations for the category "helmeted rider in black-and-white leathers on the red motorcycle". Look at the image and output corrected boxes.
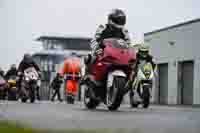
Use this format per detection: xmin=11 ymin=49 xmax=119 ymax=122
xmin=86 ymin=9 xmax=131 ymax=73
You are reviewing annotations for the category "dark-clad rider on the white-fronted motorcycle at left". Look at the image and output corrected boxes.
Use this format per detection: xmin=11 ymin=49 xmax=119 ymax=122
xmin=17 ymin=53 xmax=41 ymax=100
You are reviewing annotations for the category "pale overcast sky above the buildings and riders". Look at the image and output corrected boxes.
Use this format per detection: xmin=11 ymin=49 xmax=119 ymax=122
xmin=0 ymin=0 xmax=200 ymax=69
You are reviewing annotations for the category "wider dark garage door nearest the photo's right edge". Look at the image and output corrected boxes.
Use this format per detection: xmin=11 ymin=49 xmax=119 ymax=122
xmin=181 ymin=61 xmax=194 ymax=105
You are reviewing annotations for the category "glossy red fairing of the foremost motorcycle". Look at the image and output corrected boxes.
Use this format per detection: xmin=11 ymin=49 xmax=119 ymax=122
xmin=92 ymin=39 xmax=136 ymax=81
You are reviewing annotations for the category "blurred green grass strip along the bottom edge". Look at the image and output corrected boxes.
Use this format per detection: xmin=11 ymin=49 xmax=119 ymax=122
xmin=0 ymin=121 xmax=140 ymax=133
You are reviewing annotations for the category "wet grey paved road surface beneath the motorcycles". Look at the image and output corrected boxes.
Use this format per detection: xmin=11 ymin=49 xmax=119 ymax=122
xmin=0 ymin=101 xmax=200 ymax=133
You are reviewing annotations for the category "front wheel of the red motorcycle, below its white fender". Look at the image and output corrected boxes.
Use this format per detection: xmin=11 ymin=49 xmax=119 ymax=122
xmin=106 ymin=77 xmax=126 ymax=111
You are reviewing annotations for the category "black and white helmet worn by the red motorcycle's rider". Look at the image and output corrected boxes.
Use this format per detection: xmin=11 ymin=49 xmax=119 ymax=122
xmin=108 ymin=9 xmax=126 ymax=28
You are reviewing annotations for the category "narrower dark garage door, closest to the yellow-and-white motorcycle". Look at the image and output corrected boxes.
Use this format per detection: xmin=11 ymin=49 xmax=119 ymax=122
xmin=159 ymin=63 xmax=168 ymax=104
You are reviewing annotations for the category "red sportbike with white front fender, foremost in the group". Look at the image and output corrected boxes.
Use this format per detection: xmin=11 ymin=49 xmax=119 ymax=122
xmin=81 ymin=38 xmax=136 ymax=110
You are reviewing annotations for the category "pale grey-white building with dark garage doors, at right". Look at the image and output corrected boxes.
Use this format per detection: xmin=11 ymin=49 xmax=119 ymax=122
xmin=144 ymin=19 xmax=200 ymax=105
